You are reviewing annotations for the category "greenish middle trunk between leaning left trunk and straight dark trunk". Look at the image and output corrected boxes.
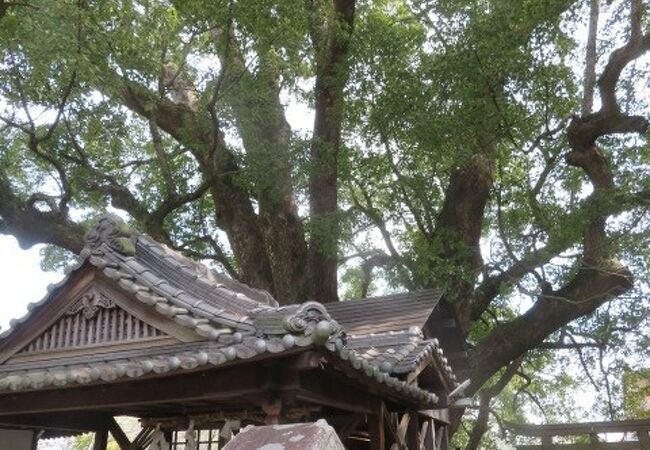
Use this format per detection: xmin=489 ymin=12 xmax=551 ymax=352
xmin=221 ymin=47 xmax=309 ymax=304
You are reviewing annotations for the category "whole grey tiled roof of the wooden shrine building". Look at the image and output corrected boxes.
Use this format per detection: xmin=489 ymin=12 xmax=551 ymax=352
xmin=0 ymin=215 xmax=454 ymax=405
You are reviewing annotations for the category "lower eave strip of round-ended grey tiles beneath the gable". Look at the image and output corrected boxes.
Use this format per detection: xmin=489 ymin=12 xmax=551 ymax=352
xmin=0 ymin=334 xmax=438 ymax=406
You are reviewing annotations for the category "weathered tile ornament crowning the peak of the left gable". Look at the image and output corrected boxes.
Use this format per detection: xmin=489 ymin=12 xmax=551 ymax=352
xmin=82 ymin=213 xmax=136 ymax=256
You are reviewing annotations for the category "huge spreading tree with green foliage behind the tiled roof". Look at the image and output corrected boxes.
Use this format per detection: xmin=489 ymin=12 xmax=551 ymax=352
xmin=0 ymin=0 xmax=650 ymax=445
